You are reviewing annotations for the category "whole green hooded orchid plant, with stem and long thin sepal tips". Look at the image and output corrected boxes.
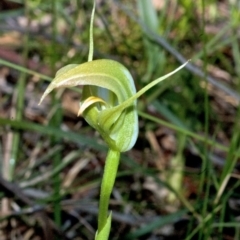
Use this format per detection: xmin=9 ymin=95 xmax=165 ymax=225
xmin=40 ymin=2 xmax=187 ymax=240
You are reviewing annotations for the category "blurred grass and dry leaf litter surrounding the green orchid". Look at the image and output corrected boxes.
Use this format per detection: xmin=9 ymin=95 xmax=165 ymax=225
xmin=0 ymin=0 xmax=240 ymax=240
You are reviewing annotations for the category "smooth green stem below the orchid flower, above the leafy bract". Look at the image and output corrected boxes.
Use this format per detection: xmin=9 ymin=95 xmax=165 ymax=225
xmin=98 ymin=149 xmax=120 ymax=233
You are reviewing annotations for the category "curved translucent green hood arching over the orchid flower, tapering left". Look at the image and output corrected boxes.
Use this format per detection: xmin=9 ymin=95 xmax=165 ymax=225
xmin=40 ymin=59 xmax=136 ymax=103
